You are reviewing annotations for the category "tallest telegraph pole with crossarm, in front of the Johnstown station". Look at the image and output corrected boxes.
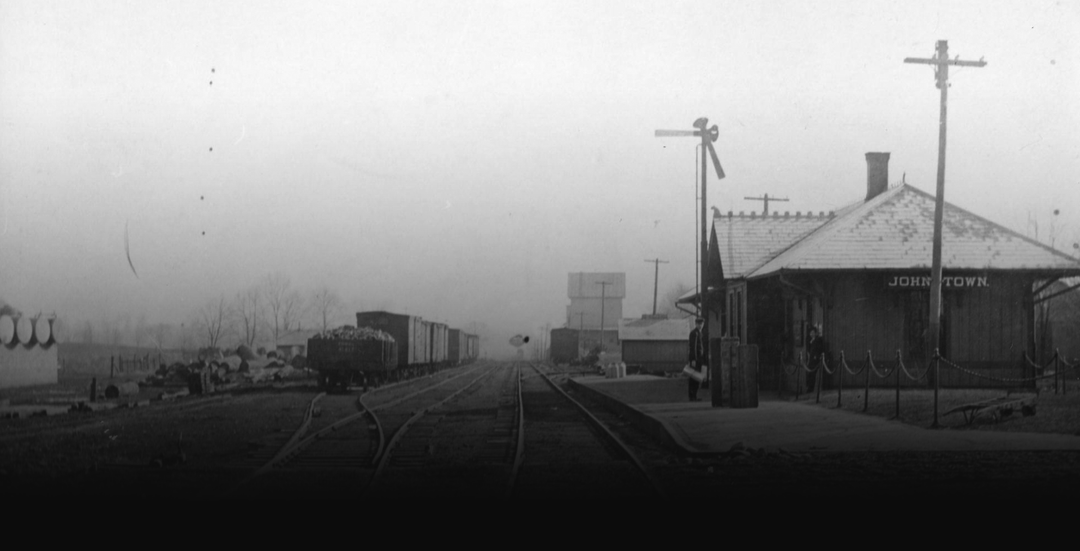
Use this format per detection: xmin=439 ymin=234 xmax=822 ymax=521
xmin=904 ymin=40 xmax=986 ymax=365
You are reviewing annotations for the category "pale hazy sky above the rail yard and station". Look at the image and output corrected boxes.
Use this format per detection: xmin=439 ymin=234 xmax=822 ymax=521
xmin=0 ymin=0 xmax=1080 ymax=352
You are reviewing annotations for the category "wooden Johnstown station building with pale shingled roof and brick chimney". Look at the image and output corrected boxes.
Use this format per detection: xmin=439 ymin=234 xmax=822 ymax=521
xmin=679 ymin=152 xmax=1080 ymax=389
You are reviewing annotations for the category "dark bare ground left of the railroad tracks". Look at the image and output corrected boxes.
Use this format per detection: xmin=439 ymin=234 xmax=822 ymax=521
xmin=0 ymin=389 xmax=315 ymax=497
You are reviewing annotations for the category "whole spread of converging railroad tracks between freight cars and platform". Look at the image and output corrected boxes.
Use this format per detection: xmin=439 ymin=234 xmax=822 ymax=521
xmin=232 ymin=363 xmax=663 ymax=499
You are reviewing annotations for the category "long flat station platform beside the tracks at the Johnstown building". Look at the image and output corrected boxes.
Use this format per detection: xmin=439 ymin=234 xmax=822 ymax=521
xmin=569 ymin=375 xmax=1080 ymax=456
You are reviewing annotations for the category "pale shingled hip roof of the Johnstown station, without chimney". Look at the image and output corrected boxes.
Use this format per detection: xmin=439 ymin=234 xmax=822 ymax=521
xmin=713 ymin=184 xmax=1080 ymax=279
